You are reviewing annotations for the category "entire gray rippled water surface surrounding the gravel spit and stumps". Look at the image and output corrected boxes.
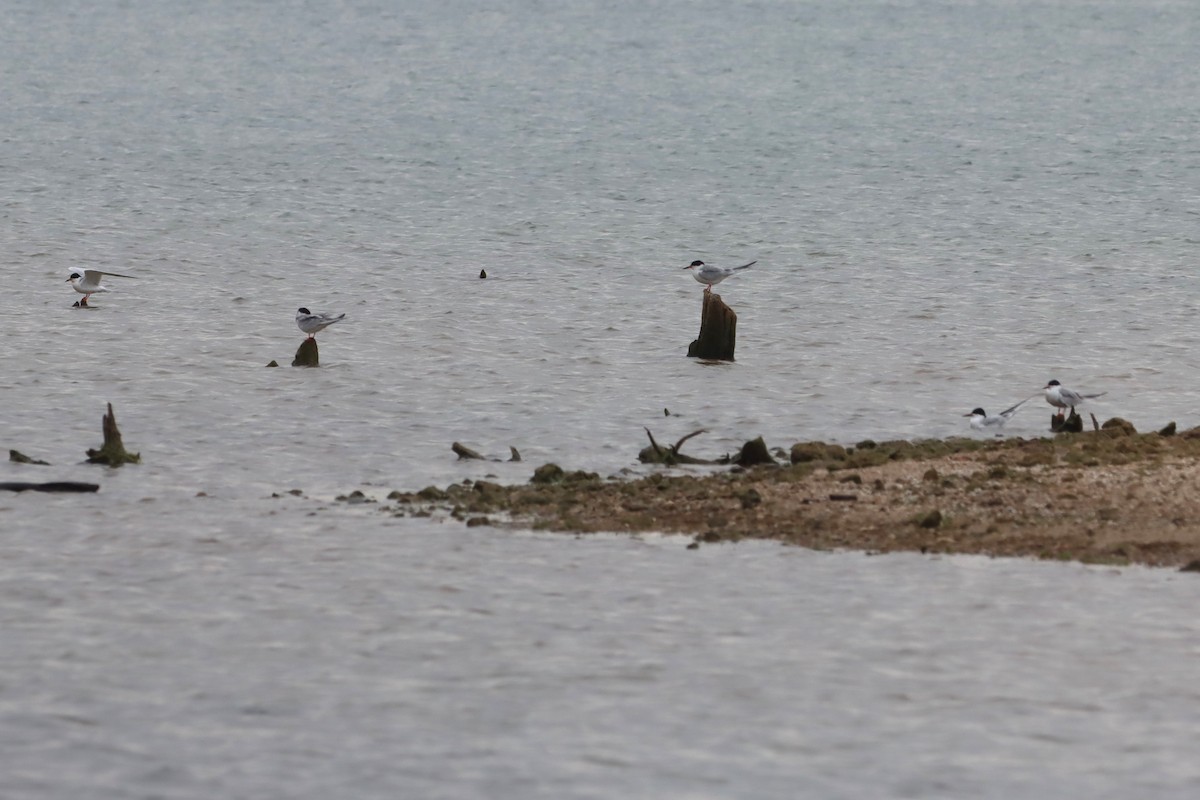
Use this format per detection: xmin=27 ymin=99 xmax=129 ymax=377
xmin=0 ymin=0 xmax=1200 ymax=798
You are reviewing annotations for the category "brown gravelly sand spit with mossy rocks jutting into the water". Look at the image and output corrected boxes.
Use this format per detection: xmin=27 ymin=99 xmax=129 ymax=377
xmin=384 ymin=427 xmax=1200 ymax=566
